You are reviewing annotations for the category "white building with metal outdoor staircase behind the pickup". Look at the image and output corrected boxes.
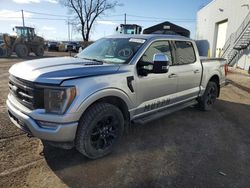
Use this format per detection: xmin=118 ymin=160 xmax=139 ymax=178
xmin=196 ymin=0 xmax=250 ymax=70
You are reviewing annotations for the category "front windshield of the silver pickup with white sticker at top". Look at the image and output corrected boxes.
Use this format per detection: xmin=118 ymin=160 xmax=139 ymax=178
xmin=76 ymin=38 xmax=145 ymax=64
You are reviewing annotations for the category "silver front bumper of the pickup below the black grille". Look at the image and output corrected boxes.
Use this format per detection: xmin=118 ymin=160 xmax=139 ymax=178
xmin=6 ymin=99 xmax=78 ymax=142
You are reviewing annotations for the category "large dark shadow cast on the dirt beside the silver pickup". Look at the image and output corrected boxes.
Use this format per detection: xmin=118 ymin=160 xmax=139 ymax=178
xmin=43 ymin=100 xmax=250 ymax=187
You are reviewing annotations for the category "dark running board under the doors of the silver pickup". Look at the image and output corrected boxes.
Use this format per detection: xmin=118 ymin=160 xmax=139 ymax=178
xmin=132 ymin=100 xmax=198 ymax=125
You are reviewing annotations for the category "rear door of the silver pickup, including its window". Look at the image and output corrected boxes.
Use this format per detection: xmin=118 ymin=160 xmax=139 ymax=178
xmin=172 ymin=41 xmax=202 ymax=102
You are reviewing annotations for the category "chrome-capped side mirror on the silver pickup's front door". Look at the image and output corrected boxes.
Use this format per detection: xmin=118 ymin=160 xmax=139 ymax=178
xmin=152 ymin=54 xmax=169 ymax=74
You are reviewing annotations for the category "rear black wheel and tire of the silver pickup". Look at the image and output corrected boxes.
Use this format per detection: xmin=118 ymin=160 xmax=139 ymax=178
xmin=198 ymin=81 xmax=219 ymax=111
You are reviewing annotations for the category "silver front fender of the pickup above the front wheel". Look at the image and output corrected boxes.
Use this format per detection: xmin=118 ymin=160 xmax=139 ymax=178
xmin=62 ymin=65 xmax=136 ymax=118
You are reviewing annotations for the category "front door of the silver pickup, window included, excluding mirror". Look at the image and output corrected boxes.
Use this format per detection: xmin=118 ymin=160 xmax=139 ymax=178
xmin=135 ymin=40 xmax=178 ymax=115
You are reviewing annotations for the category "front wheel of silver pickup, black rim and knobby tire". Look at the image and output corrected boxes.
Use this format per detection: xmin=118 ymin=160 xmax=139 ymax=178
xmin=76 ymin=103 xmax=124 ymax=159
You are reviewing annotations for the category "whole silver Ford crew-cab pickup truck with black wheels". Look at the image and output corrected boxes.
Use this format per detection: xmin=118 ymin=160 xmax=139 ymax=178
xmin=7 ymin=35 xmax=226 ymax=159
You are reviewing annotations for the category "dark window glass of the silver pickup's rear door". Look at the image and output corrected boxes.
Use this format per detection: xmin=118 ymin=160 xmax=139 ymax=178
xmin=174 ymin=41 xmax=196 ymax=65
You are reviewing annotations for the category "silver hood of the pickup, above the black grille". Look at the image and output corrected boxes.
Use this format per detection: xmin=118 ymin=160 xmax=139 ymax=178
xmin=9 ymin=57 xmax=120 ymax=84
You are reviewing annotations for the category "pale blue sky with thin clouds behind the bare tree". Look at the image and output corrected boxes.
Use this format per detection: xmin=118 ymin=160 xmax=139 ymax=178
xmin=0 ymin=0 xmax=211 ymax=40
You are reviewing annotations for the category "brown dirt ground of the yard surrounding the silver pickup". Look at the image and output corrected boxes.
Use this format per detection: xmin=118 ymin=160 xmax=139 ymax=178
xmin=0 ymin=53 xmax=250 ymax=188
